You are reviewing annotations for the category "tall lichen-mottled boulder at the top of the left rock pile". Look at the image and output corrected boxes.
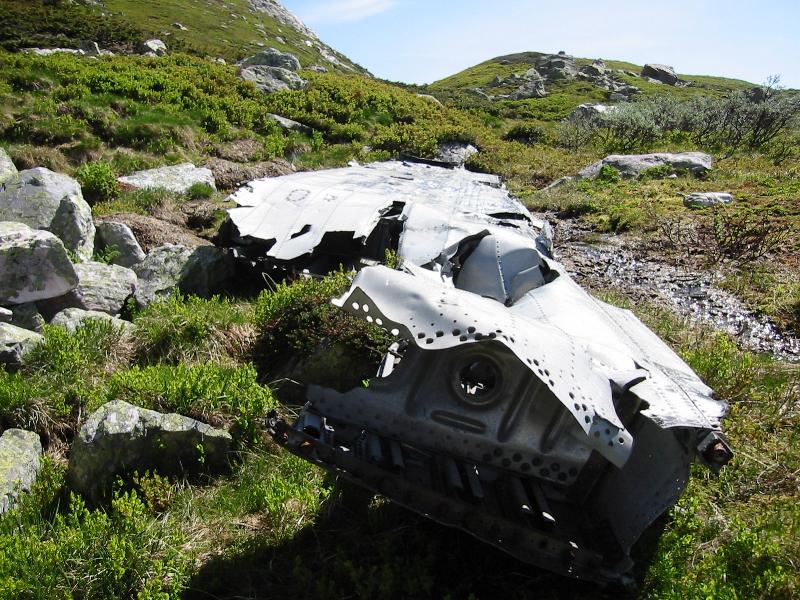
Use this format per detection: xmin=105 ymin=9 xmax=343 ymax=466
xmin=0 ymin=167 xmax=95 ymax=262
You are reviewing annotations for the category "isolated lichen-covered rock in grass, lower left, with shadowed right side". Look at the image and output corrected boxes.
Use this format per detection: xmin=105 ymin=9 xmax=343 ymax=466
xmin=67 ymin=400 xmax=232 ymax=501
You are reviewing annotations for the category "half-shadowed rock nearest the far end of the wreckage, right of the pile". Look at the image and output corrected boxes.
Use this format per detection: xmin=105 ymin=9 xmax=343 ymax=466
xmin=134 ymin=244 xmax=235 ymax=306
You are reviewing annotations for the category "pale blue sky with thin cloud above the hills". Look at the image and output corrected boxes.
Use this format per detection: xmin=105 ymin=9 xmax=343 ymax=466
xmin=283 ymin=0 xmax=800 ymax=88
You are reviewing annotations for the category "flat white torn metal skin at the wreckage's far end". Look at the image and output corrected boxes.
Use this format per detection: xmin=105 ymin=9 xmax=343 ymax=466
xmin=229 ymin=161 xmax=549 ymax=265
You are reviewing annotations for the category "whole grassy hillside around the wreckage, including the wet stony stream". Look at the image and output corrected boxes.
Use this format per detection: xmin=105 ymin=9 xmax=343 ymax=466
xmin=0 ymin=0 xmax=800 ymax=600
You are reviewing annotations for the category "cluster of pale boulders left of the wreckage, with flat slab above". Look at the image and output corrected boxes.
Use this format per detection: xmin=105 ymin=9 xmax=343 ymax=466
xmin=0 ymin=150 xmax=233 ymax=369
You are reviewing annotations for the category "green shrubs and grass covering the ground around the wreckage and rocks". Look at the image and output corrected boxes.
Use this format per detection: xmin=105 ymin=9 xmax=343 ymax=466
xmin=0 ymin=0 xmax=800 ymax=600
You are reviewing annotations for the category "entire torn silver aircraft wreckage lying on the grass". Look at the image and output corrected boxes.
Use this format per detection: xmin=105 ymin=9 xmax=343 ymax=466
xmin=223 ymin=161 xmax=731 ymax=582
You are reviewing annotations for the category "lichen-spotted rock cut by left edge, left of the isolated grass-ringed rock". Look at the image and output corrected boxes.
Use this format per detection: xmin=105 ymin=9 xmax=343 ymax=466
xmin=0 ymin=429 xmax=42 ymax=513
